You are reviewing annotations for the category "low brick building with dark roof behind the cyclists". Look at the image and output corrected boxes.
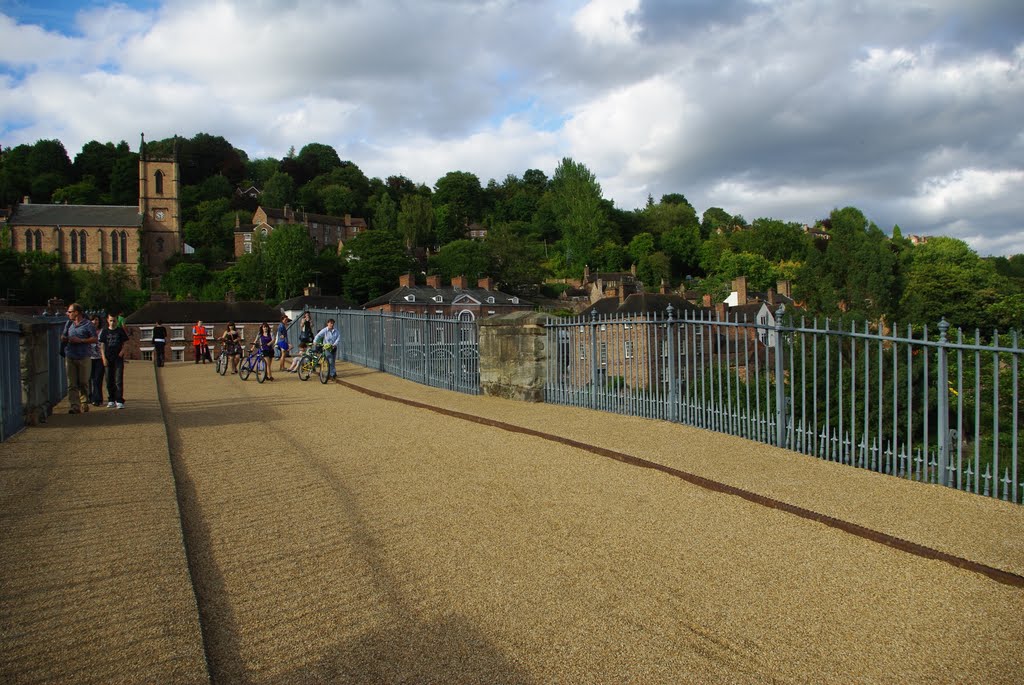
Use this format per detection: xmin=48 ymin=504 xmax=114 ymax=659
xmin=125 ymin=298 xmax=281 ymax=361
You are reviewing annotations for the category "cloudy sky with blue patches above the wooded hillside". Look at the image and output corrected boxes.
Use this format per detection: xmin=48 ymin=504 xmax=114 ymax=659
xmin=6 ymin=0 xmax=1024 ymax=256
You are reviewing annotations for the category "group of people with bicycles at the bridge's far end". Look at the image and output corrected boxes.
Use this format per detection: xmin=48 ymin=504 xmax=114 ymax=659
xmin=207 ymin=311 xmax=341 ymax=383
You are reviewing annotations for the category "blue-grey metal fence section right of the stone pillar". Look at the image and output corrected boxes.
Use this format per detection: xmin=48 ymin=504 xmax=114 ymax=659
xmin=545 ymin=307 xmax=1024 ymax=502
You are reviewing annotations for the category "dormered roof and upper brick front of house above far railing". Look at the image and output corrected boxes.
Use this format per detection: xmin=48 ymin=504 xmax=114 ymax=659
xmin=362 ymin=273 xmax=534 ymax=320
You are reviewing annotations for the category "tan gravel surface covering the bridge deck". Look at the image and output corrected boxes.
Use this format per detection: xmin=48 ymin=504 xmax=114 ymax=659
xmin=0 ymin=365 xmax=1024 ymax=683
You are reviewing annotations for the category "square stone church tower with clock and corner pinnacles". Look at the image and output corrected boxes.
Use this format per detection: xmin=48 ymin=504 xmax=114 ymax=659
xmin=138 ymin=134 xmax=184 ymax=276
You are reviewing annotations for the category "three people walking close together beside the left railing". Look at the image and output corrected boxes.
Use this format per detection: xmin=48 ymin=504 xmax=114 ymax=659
xmin=60 ymin=302 xmax=130 ymax=414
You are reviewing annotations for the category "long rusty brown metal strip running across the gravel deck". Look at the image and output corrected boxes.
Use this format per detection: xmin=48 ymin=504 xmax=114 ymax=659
xmin=341 ymin=380 xmax=1024 ymax=588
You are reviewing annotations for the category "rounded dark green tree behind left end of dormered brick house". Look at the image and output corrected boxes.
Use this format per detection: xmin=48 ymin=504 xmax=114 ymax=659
xmin=342 ymin=230 xmax=414 ymax=304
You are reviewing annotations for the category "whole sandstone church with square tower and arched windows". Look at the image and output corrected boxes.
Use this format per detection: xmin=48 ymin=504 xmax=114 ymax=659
xmin=7 ymin=136 xmax=184 ymax=282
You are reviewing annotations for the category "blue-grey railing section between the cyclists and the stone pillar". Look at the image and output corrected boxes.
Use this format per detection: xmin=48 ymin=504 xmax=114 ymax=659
xmin=288 ymin=309 xmax=480 ymax=394
